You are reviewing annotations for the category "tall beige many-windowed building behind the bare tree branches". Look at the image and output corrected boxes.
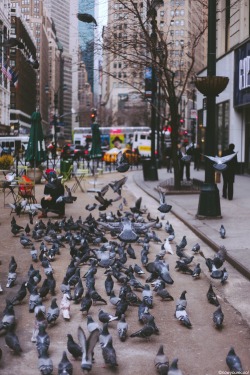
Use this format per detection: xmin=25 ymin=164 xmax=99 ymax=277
xmin=101 ymin=0 xmax=207 ymax=130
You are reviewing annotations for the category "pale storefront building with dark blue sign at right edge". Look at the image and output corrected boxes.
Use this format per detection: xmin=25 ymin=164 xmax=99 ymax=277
xmin=197 ymin=0 xmax=250 ymax=173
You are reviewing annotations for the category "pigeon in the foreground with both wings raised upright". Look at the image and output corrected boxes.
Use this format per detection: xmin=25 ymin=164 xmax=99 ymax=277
xmin=78 ymin=326 xmax=99 ymax=371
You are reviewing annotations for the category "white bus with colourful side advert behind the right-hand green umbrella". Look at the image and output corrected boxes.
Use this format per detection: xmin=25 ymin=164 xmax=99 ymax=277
xmin=73 ymin=126 xmax=150 ymax=150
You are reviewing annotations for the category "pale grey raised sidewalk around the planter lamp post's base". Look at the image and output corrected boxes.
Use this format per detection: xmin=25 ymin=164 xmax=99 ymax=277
xmin=134 ymin=165 xmax=250 ymax=279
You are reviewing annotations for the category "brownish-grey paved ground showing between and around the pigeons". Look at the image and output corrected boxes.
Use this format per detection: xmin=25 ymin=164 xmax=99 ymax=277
xmin=0 ymin=172 xmax=250 ymax=375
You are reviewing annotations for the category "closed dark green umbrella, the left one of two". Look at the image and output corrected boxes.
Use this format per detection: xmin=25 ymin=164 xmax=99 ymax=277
xmin=25 ymin=112 xmax=47 ymax=185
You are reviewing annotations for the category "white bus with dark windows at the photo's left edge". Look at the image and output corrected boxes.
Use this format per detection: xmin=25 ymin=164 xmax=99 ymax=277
xmin=0 ymin=135 xmax=29 ymax=155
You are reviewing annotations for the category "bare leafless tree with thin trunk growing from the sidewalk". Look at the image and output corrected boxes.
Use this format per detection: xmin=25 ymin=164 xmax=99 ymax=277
xmin=100 ymin=0 xmax=210 ymax=188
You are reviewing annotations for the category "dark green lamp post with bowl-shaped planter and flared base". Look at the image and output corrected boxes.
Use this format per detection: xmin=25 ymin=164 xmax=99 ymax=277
xmin=195 ymin=0 xmax=228 ymax=218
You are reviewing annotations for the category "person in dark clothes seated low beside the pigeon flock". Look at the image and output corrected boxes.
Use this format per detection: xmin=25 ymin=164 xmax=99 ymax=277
xmin=38 ymin=172 xmax=65 ymax=219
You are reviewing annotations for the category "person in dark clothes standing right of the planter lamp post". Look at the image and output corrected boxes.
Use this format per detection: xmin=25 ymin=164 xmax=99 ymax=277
xmin=222 ymin=143 xmax=238 ymax=201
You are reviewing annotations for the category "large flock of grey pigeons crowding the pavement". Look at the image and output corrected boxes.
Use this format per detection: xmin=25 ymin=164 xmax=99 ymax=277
xmin=0 ymin=177 xmax=246 ymax=375
